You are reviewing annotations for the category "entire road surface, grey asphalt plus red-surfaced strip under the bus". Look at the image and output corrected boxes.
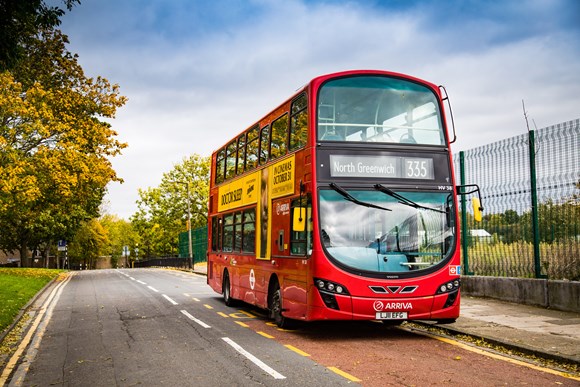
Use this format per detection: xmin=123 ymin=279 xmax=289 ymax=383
xmin=10 ymin=269 xmax=579 ymax=386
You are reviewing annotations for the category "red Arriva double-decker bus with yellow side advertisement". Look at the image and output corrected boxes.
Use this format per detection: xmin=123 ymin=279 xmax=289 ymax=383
xmin=207 ymin=70 xmax=480 ymax=327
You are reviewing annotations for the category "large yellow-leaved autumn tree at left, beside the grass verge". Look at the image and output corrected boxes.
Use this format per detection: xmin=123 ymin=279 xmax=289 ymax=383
xmin=0 ymin=31 xmax=126 ymax=263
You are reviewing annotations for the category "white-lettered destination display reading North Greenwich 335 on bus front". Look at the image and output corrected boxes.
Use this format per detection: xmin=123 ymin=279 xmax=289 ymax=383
xmin=330 ymin=155 xmax=435 ymax=180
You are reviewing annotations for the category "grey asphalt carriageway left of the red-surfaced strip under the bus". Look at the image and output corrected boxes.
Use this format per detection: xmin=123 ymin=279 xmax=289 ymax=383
xmin=13 ymin=269 xmax=348 ymax=386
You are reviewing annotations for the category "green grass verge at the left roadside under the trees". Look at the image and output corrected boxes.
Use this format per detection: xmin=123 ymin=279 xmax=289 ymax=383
xmin=0 ymin=268 xmax=64 ymax=332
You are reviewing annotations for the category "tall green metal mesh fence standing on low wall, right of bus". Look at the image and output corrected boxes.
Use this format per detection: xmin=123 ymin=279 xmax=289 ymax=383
xmin=455 ymin=119 xmax=580 ymax=280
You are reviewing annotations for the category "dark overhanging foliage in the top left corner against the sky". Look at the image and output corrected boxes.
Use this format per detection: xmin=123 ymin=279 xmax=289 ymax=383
xmin=0 ymin=0 xmax=80 ymax=71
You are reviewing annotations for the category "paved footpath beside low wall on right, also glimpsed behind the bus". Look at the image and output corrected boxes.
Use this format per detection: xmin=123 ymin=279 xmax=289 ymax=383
xmin=193 ymin=263 xmax=580 ymax=365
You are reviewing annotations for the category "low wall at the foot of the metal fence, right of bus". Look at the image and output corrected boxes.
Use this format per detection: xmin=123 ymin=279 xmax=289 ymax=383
xmin=461 ymin=276 xmax=580 ymax=313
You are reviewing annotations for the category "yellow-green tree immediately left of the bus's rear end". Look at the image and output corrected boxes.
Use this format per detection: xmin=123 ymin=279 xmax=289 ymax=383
xmin=131 ymin=154 xmax=210 ymax=256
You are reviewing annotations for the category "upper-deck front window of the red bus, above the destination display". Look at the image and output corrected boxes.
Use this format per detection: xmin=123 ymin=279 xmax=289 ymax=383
xmin=317 ymin=76 xmax=445 ymax=145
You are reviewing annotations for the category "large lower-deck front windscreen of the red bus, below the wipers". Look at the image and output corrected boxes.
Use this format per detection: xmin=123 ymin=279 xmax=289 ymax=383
xmin=320 ymin=189 xmax=455 ymax=275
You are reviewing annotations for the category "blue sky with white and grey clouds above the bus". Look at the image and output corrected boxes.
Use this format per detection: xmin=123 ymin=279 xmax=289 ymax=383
xmin=57 ymin=0 xmax=580 ymax=220
